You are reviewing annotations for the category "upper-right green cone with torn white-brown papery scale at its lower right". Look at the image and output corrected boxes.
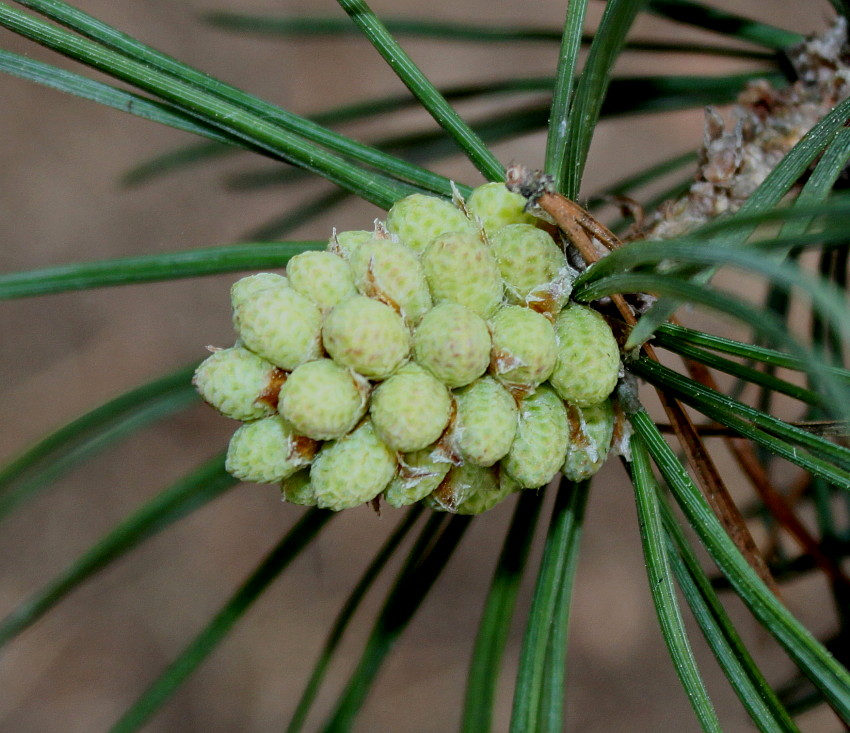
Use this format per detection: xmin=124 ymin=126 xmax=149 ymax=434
xmin=490 ymin=224 xmax=572 ymax=312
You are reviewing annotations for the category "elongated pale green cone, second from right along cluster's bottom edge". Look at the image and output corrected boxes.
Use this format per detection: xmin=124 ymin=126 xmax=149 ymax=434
xmin=501 ymin=384 xmax=570 ymax=489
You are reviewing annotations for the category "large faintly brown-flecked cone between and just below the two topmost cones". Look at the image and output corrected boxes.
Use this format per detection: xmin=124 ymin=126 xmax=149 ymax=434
xmin=422 ymin=232 xmax=503 ymax=318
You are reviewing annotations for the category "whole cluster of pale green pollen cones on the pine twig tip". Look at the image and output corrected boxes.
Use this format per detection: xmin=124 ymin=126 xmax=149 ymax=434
xmin=194 ymin=183 xmax=620 ymax=514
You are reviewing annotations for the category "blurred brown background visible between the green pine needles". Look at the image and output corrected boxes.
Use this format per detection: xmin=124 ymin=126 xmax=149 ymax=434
xmin=0 ymin=0 xmax=839 ymax=733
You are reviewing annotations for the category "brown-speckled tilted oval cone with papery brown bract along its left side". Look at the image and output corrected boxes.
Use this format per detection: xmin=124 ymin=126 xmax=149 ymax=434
xmin=350 ymin=239 xmax=431 ymax=325
